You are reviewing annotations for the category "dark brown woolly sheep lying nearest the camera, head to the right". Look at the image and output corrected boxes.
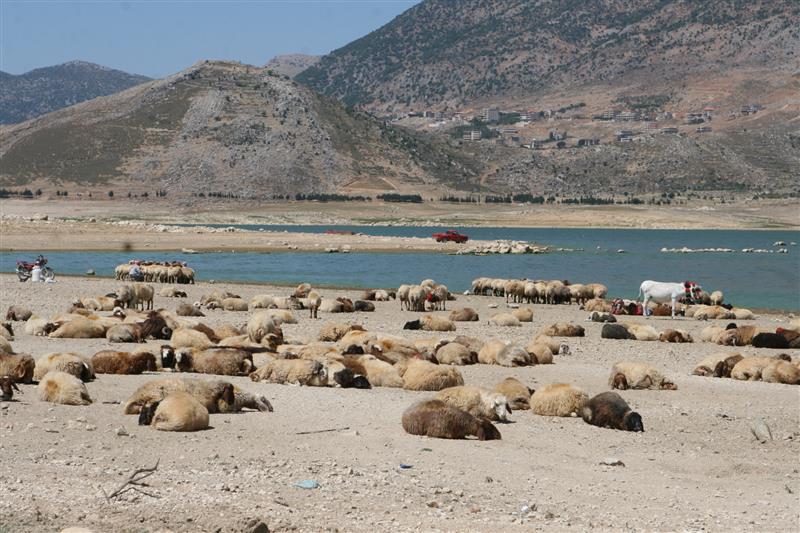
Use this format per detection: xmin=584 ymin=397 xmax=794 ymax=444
xmin=402 ymin=400 xmax=501 ymax=440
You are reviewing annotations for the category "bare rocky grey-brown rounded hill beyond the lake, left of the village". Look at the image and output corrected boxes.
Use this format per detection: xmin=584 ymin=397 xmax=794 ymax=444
xmin=0 ymin=61 xmax=481 ymax=198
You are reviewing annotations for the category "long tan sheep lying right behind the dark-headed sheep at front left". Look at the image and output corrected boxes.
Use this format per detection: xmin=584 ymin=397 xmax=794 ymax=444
xmin=123 ymin=378 xmax=272 ymax=415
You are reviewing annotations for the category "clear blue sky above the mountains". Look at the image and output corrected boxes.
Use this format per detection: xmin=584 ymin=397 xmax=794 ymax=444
xmin=0 ymin=0 xmax=419 ymax=78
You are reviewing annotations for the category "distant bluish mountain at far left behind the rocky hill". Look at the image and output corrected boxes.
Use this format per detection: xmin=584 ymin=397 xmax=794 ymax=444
xmin=0 ymin=61 xmax=150 ymax=124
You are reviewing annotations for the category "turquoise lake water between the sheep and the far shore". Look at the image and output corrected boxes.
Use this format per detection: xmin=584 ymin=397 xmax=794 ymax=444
xmin=0 ymin=226 xmax=800 ymax=310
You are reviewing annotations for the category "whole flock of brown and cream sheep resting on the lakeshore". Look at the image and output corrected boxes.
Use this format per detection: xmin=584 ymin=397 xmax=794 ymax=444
xmin=0 ymin=274 xmax=800 ymax=440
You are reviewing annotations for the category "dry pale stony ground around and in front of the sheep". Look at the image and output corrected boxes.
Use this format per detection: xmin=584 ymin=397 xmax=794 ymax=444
xmin=0 ymin=275 xmax=800 ymax=532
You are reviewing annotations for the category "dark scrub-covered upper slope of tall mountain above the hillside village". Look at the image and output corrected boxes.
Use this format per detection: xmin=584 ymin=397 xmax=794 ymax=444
xmin=296 ymin=0 xmax=800 ymax=111
